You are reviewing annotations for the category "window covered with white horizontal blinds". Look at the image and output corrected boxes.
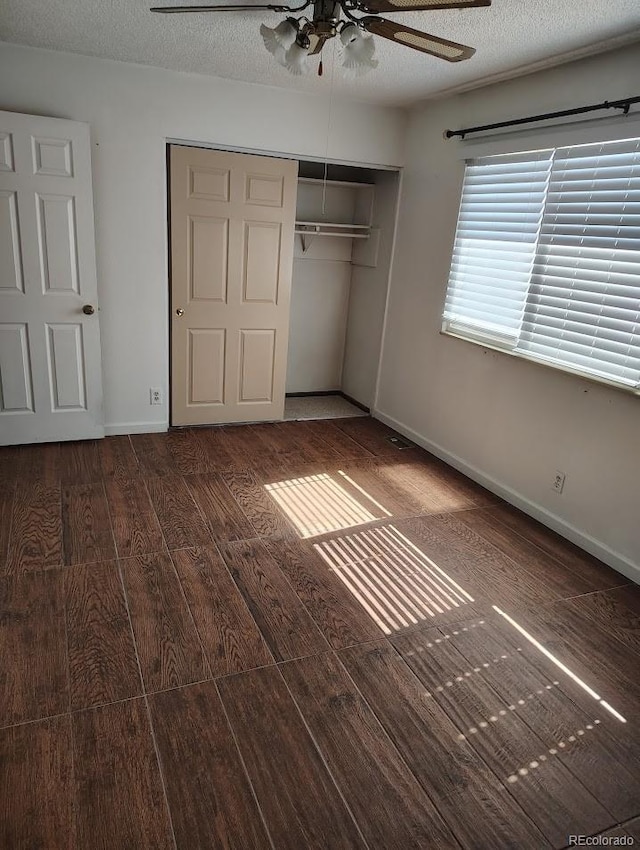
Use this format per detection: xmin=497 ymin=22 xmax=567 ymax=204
xmin=442 ymin=139 xmax=640 ymax=392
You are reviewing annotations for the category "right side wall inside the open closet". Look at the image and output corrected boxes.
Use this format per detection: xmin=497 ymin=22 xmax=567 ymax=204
xmin=342 ymin=172 xmax=399 ymax=408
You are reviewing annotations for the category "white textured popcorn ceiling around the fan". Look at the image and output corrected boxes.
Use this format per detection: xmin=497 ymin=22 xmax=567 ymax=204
xmin=0 ymin=0 xmax=640 ymax=106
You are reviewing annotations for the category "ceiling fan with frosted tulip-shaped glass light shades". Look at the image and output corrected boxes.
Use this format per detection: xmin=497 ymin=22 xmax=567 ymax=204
xmin=151 ymin=0 xmax=491 ymax=75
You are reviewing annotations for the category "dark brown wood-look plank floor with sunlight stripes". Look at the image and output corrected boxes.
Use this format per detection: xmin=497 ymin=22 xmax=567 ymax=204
xmin=0 ymin=417 xmax=640 ymax=850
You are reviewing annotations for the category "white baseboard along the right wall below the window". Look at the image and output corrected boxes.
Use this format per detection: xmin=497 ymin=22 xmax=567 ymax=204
xmin=371 ymin=410 xmax=640 ymax=584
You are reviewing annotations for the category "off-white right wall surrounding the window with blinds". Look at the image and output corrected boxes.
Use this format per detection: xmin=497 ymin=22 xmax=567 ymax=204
xmin=377 ymin=45 xmax=640 ymax=581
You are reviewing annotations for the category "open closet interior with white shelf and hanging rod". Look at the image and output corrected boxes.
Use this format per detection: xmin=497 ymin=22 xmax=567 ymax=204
xmin=286 ymin=162 xmax=399 ymax=408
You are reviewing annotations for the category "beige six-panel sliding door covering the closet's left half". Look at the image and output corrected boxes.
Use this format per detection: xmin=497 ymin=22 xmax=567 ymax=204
xmin=170 ymin=145 xmax=298 ymax=425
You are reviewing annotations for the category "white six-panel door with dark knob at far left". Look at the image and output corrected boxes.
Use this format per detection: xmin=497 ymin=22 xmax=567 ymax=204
xmin=0 ymin=112 xmax=104 ymax=445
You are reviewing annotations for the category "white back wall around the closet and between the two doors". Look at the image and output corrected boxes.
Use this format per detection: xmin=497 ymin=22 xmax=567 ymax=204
xmin=0 ymin=44 xmax=405 ymax=433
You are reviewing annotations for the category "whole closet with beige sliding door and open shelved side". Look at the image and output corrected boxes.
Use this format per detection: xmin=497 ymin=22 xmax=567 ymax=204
xmin=168 ymin=145 xmax=399 ymax=426
